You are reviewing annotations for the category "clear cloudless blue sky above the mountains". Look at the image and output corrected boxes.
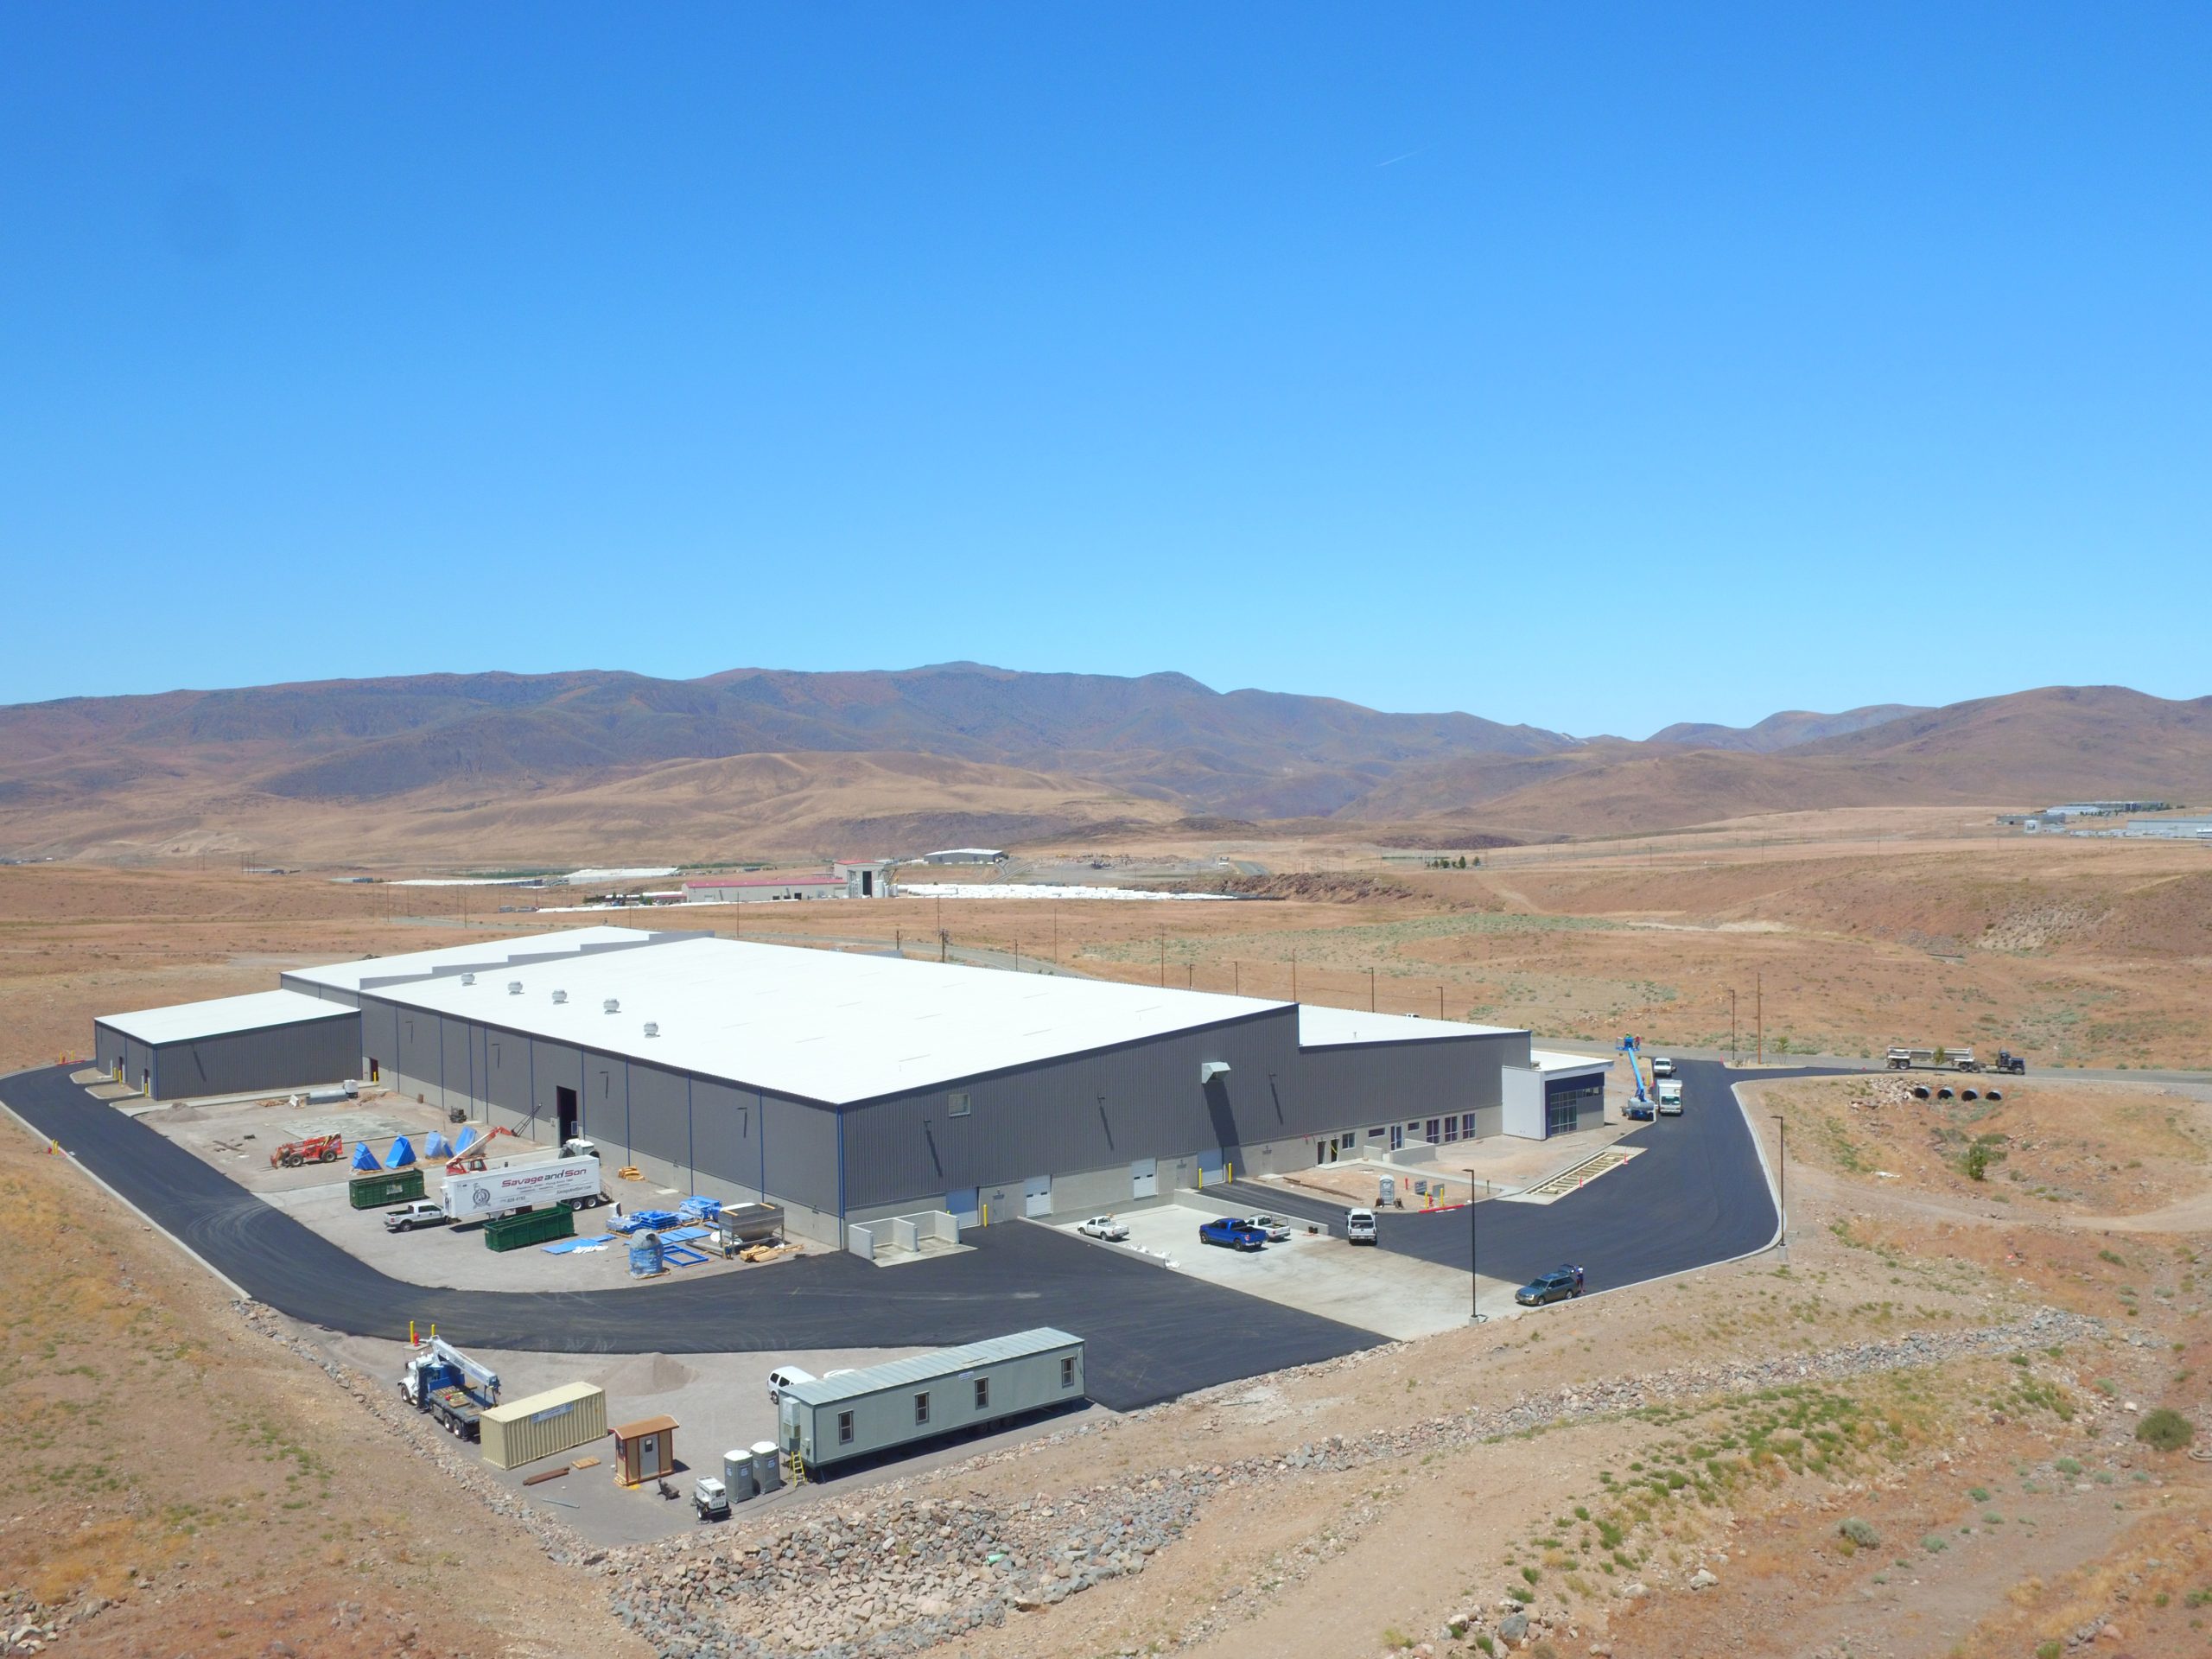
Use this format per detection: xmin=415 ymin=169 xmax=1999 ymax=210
xmin=0 ymin=3 xmax=2212 ymax=736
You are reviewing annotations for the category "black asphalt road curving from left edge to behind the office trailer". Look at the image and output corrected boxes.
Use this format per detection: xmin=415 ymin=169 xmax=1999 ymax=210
xmin=0 ymin=1066 xmax=1380 ymax=1411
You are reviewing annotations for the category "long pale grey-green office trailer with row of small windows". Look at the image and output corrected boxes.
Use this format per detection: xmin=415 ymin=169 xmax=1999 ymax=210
xmin=779 ymin=1325 xmax=1086 ymax=1469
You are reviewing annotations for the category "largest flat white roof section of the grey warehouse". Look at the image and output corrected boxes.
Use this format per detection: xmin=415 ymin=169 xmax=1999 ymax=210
xmin=370 ymin=936 xmax=1289 ymax=1103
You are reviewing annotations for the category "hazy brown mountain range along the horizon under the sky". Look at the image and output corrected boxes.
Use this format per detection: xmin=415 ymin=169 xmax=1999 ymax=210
xmin=0 ymin=664 xmax=2212 ymax=862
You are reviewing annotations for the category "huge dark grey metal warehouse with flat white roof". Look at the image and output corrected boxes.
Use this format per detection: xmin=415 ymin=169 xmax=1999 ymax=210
xmin=102 ymin=927 xmax=1606 ymax=1241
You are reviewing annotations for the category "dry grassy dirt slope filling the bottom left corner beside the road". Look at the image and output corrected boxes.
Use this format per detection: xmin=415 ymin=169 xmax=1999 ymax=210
xmin=0 ymin=1122 xmax=648 ymax=1659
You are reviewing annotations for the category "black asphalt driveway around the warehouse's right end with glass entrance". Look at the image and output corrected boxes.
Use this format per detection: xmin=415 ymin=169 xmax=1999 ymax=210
xmin=1217 ymin=1059 xmax=1825 ymax=1289
